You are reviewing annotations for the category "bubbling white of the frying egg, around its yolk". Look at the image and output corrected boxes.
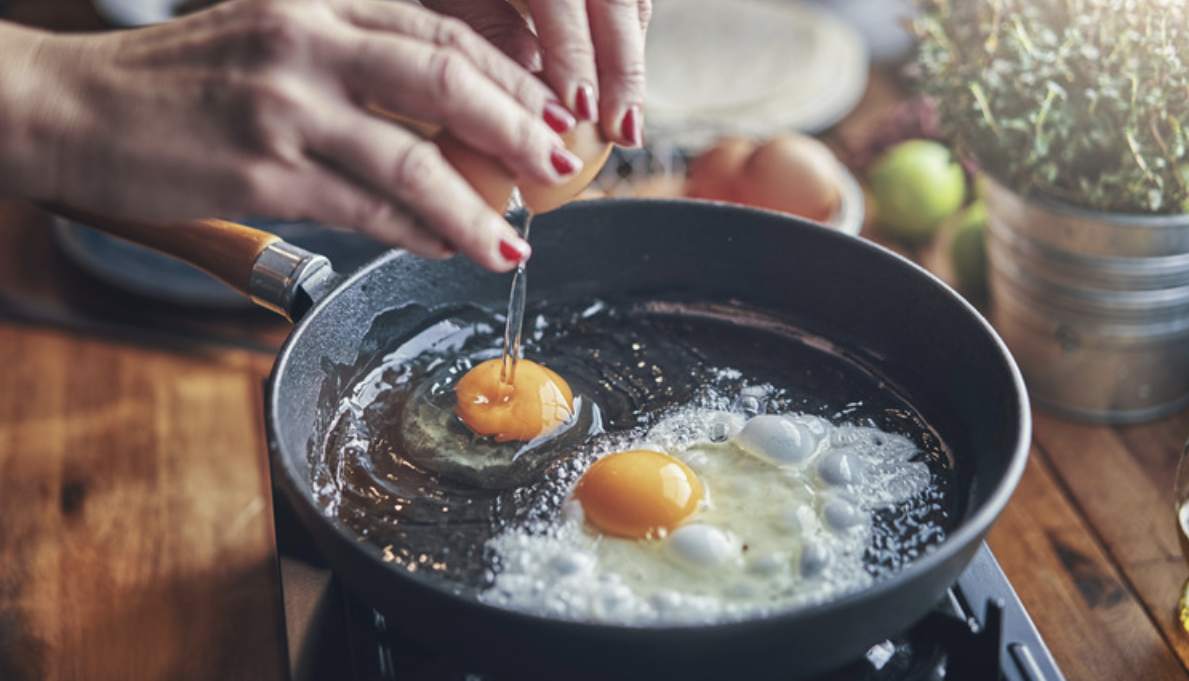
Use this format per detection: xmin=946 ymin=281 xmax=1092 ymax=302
xmin=480 ymin=408 xmax=942 ymax=624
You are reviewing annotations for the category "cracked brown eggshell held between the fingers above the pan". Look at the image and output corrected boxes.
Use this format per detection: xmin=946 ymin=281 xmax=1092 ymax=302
xmin=434 ymin=121 xmax=611 ymax=214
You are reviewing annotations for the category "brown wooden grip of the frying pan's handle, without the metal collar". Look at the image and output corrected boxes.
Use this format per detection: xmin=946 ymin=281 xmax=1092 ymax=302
xmin=44 ymin=204 xmax=281 ymax=295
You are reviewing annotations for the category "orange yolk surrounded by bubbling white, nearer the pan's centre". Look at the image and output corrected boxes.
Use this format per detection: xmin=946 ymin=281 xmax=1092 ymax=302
xmin=574 ymin=449 xmax=702 ymax=540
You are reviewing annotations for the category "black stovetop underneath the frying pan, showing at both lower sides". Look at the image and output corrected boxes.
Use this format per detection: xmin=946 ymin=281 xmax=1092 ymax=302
xmin=277 ymin=499 xmax=1064 ymax=681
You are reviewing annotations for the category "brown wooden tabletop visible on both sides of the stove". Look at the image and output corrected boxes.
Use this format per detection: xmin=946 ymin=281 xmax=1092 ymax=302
xmin=0 ymin=5 xmax=1189 ymax=681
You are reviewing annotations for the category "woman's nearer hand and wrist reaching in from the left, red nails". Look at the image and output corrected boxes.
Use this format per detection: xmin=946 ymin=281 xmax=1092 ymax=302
xmin=0 ymin=0 xmax=580 ymax=271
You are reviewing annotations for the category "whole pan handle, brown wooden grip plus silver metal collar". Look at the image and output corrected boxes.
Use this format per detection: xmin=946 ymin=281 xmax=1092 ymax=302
xmin=44 ymin=204 xmax=338 ymax=321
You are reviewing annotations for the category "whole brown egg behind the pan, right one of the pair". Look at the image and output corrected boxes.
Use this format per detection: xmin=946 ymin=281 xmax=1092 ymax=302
xmin=738 ymin=133 xmax=842 ymax=222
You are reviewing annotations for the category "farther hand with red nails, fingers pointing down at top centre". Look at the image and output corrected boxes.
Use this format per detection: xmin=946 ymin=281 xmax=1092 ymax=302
xmin=423 ymin=0 xmax=652 ymax=146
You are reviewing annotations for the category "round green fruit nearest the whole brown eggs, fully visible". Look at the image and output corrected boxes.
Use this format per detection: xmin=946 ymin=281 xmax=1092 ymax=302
xmin=867 ymin=139 xmax=967 ymax=244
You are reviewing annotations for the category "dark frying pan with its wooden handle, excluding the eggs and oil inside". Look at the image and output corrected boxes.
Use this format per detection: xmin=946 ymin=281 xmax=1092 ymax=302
xmin=67 ymin=200 xmax=1031 ymax=680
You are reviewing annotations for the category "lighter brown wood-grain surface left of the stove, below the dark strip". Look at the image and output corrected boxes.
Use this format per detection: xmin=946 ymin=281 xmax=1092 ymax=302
xmin=0 ymin=326 xmax=283 ymax=681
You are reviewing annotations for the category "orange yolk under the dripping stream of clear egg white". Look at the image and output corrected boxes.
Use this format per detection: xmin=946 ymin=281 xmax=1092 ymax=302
xmin=454 ymin=358 xmax=574 ymax=442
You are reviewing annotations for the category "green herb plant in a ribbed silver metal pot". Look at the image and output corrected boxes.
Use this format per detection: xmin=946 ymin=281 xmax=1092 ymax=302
xmin=913 ymin=0 xmax=1189 ymax=422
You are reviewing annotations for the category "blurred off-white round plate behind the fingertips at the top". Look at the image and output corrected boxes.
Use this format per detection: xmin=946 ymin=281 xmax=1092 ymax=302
xmin=644 ymin=0 xmax=868 ymax=147
